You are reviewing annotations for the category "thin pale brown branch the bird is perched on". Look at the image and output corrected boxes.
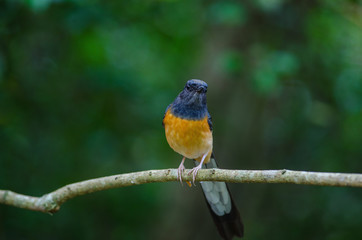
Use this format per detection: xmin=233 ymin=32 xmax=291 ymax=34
xmin=0 ymin=169 xmax=362 ymax=213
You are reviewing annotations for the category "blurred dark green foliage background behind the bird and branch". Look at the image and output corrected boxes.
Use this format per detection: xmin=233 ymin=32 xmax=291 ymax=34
xmin=0 ymin=0 xmax=362 ymax=240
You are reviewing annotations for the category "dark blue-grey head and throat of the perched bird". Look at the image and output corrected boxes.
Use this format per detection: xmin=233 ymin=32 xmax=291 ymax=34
xmin=171 ymin=79 xmax=207 ymax=120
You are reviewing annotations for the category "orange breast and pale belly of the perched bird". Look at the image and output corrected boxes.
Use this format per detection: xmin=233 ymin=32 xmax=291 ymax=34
xmin=163 ymin=109 xmax=213 ymax=163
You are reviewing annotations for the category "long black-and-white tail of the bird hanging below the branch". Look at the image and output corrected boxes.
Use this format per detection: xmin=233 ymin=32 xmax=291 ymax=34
xmin=195 ymin=154 xmax=244 ymax=240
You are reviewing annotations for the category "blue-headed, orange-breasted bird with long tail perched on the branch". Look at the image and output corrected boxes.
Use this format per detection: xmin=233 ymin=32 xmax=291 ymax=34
xmin=162 ymin=79 xmax=244 ymax=240
